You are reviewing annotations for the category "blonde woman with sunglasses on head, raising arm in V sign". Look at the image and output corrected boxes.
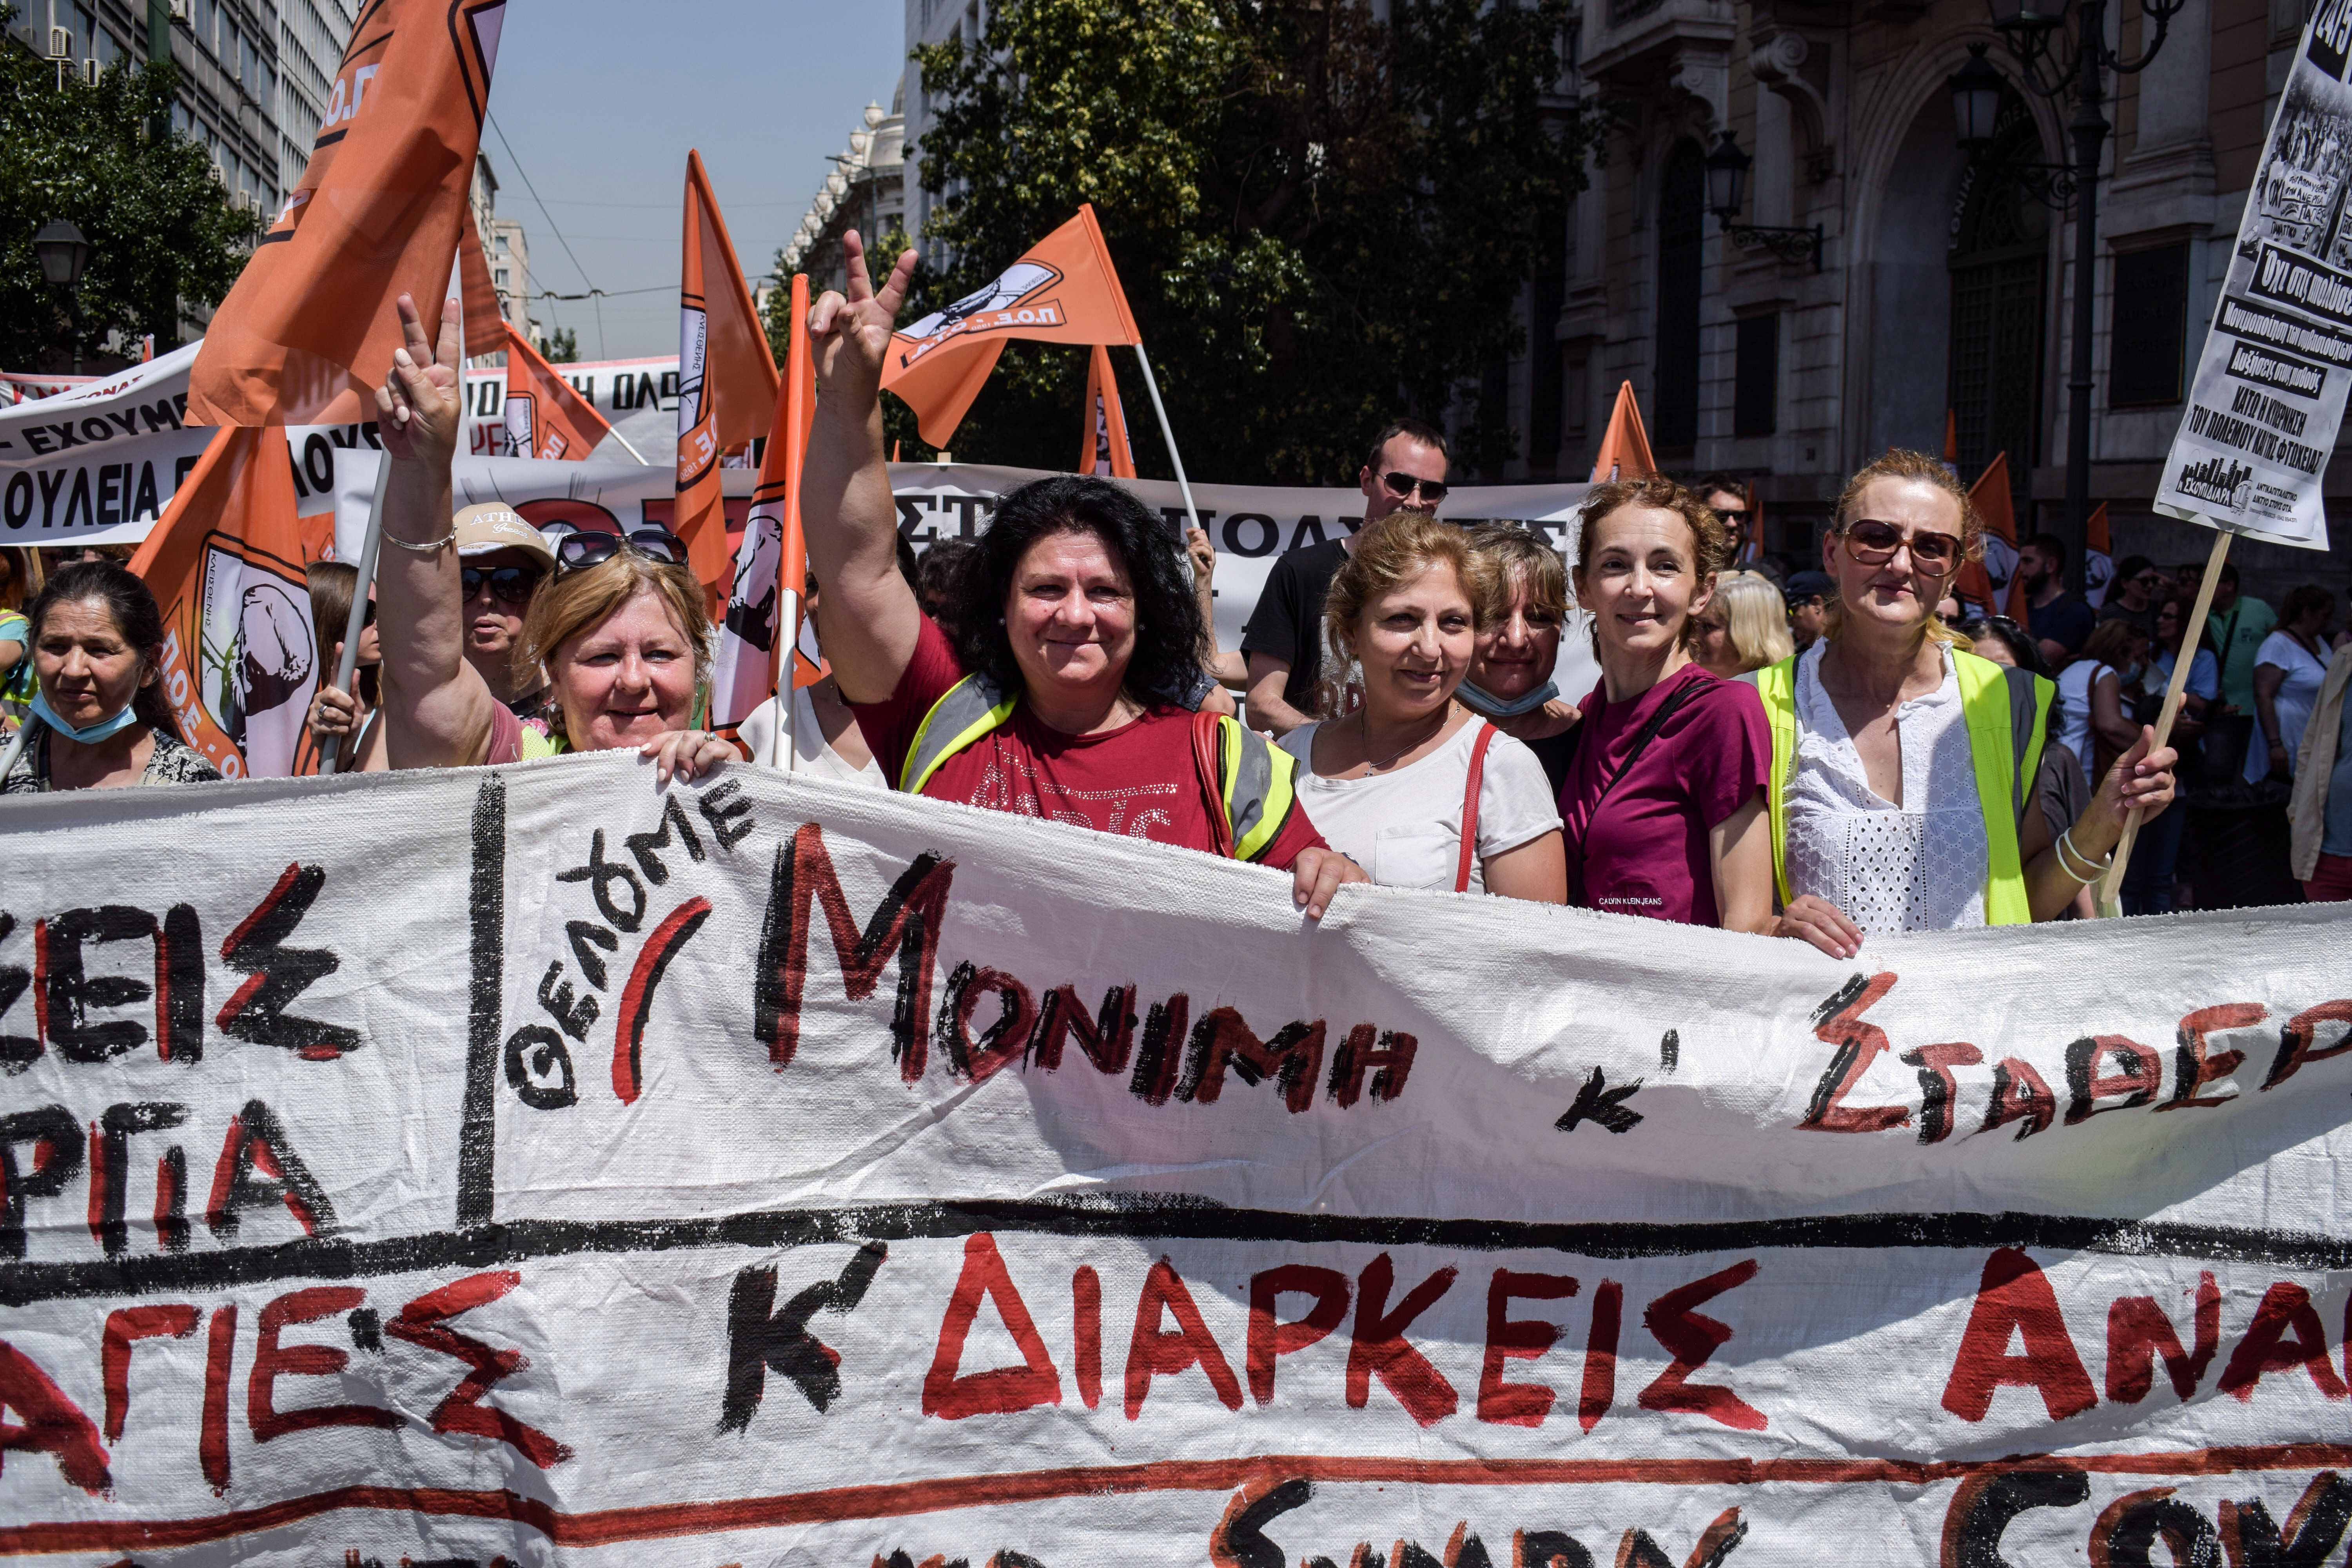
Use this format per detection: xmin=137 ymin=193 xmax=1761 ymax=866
xmin=376 ymin=294 xmax=736 ymax=783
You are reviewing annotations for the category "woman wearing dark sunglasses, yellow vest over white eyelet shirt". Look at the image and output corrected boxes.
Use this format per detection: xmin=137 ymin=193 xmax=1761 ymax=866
xmin=1757 ymin=449 xmax=2173 ymax=959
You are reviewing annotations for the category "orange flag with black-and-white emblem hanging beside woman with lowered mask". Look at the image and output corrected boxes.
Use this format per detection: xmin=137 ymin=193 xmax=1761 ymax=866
xmin=132 ymin=425 xmax=320 ymax=778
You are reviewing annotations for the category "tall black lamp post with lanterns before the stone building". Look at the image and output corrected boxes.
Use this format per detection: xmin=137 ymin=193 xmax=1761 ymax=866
xmin=1947 ymin=0 xmax=2185 ymax=592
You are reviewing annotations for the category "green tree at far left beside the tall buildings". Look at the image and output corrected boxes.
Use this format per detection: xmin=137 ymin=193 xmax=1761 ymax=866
xmin=0 ymin=7 xmax=263 ymax=367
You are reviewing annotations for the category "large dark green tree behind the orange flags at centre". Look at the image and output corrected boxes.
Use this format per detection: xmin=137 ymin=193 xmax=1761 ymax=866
xmin=891 ymin=0 xmax=1599 ymax=482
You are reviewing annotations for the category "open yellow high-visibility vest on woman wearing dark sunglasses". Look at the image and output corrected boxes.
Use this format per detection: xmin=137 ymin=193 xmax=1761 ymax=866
xmin=1757 ymin=649 xmax=2058 ymax=926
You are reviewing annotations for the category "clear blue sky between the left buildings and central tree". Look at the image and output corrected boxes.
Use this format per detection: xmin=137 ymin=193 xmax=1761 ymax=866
xmin=482 ymin=0 xmax=906 ymax=360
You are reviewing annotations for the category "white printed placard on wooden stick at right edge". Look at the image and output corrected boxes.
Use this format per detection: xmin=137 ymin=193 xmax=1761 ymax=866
xmin=2154 ymin=0 xmax=2352 ymax=550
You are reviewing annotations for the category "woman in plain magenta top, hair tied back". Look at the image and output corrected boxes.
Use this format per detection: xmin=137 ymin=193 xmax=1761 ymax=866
xmin=1559 ymin=477 xmax=1773 ymax=931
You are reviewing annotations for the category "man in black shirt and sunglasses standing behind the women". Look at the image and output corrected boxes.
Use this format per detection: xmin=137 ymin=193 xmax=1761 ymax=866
xmin=1242 ymin=418 xmax=1446 ymax=736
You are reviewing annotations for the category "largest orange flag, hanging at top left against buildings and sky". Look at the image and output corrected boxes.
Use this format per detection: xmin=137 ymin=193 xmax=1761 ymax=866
xmin=186 ymin=0 xmax=506 ymax=425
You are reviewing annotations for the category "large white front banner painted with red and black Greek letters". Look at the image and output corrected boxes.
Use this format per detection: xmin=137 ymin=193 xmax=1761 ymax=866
xmin=0 ymin=757 xmax=2352 ymax=1568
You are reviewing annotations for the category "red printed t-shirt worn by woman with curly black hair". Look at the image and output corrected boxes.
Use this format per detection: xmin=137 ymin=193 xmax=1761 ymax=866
xmin=849 ymin=616 xmax=1324 ymax=870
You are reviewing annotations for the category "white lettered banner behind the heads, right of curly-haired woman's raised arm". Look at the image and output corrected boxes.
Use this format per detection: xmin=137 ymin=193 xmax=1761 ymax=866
xmin=889 ymin=463 xmax=1592 ymax=698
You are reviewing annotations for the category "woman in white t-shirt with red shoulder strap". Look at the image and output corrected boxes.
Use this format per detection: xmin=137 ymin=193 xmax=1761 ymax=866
xmin=1282 ymin=512 xmax=1569 ymax=903
